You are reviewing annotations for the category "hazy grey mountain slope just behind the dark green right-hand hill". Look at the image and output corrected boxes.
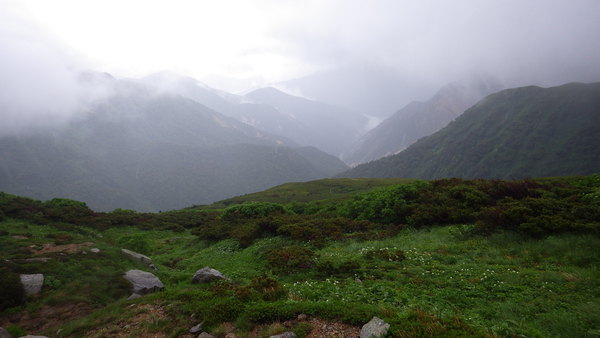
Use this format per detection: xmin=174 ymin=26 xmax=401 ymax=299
xmin=345 ymin=79 xmax=500 ymax=164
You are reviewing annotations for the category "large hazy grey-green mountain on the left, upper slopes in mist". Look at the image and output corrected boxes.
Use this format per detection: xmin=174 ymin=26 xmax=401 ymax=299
xmin=0 ymin=76 xmax=347 ymax=211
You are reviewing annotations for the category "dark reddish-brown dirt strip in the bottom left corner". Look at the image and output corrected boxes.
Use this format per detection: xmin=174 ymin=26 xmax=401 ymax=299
xmin=0 ymin=303 xmax=94 ymax=333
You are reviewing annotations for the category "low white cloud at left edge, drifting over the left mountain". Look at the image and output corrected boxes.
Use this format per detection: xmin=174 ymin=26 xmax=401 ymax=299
xmin=0 ymin=4 xmax=107 ymax=136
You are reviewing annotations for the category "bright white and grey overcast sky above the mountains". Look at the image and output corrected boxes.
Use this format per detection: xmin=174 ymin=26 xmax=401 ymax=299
xmin=0 ymin=0 xmax=600 ymax=125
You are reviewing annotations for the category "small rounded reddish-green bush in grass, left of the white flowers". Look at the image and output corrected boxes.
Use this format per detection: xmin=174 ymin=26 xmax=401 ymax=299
xmin=266 ymin=245 xmax=315 ymax=273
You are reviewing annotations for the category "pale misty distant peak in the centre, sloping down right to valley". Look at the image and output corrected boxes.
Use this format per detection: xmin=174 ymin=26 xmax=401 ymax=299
xmin=244 ymin=87 xmax=368 ymax=156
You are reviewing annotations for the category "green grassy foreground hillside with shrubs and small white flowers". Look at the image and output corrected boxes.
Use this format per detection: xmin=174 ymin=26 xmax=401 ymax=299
xmin=0 ymin=175 xmax=600 ymax=337
